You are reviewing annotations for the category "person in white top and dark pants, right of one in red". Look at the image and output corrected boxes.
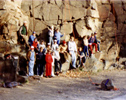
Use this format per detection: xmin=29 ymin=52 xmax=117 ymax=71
xmin=54 ymin=48 xmax=62 ymax=75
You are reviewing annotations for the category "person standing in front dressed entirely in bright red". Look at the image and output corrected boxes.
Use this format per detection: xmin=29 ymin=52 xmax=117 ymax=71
xmin=45 ymin=50 xmax=53 ymax=77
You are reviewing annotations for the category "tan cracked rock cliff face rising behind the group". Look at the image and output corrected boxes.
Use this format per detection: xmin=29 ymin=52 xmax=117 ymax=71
xmin=0 ymin=0 xmax=126 ymax=72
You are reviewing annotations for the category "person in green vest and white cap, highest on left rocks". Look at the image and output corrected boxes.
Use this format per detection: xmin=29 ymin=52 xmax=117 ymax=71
xmin=19 ymin=21 xmax=28 ymax=46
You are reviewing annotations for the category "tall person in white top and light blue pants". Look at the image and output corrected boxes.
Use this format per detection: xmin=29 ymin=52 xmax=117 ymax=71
xmin=68 ymin=36 xmax=77 ymax=68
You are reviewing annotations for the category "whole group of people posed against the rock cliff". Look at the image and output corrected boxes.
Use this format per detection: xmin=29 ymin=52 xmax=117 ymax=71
xmin=19 ymin=22 xmax=100 ymax=77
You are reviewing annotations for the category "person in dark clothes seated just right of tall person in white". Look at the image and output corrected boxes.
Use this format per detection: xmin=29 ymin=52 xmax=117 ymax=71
xmin=78 ymin=47 xmax=85 ymax=67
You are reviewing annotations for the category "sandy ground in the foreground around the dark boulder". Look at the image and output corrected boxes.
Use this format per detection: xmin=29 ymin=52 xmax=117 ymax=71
xmin=0 ymin=70 xmax=126 ymax=100
